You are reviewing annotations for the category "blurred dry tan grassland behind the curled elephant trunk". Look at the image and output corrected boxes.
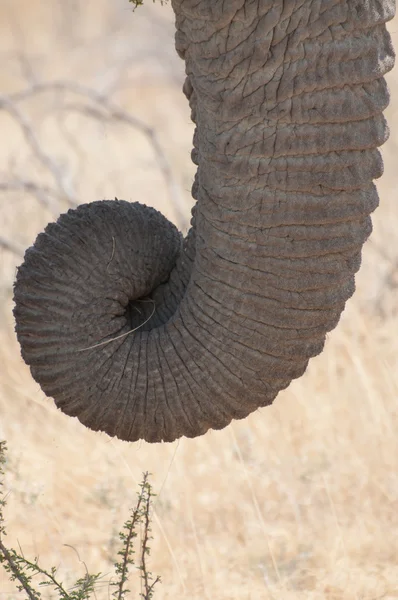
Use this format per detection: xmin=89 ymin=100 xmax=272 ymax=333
xmin=0 ymin=0 xmax=398 ymax=600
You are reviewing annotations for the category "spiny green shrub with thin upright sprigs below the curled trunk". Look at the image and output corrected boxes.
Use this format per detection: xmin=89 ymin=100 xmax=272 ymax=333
xmin=0 ymin=441 xmax=160 ymax=600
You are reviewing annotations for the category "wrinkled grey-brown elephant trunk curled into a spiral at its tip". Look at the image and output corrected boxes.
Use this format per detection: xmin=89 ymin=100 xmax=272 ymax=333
xmin=14 ymin=0 xmax=394 ymax=442
